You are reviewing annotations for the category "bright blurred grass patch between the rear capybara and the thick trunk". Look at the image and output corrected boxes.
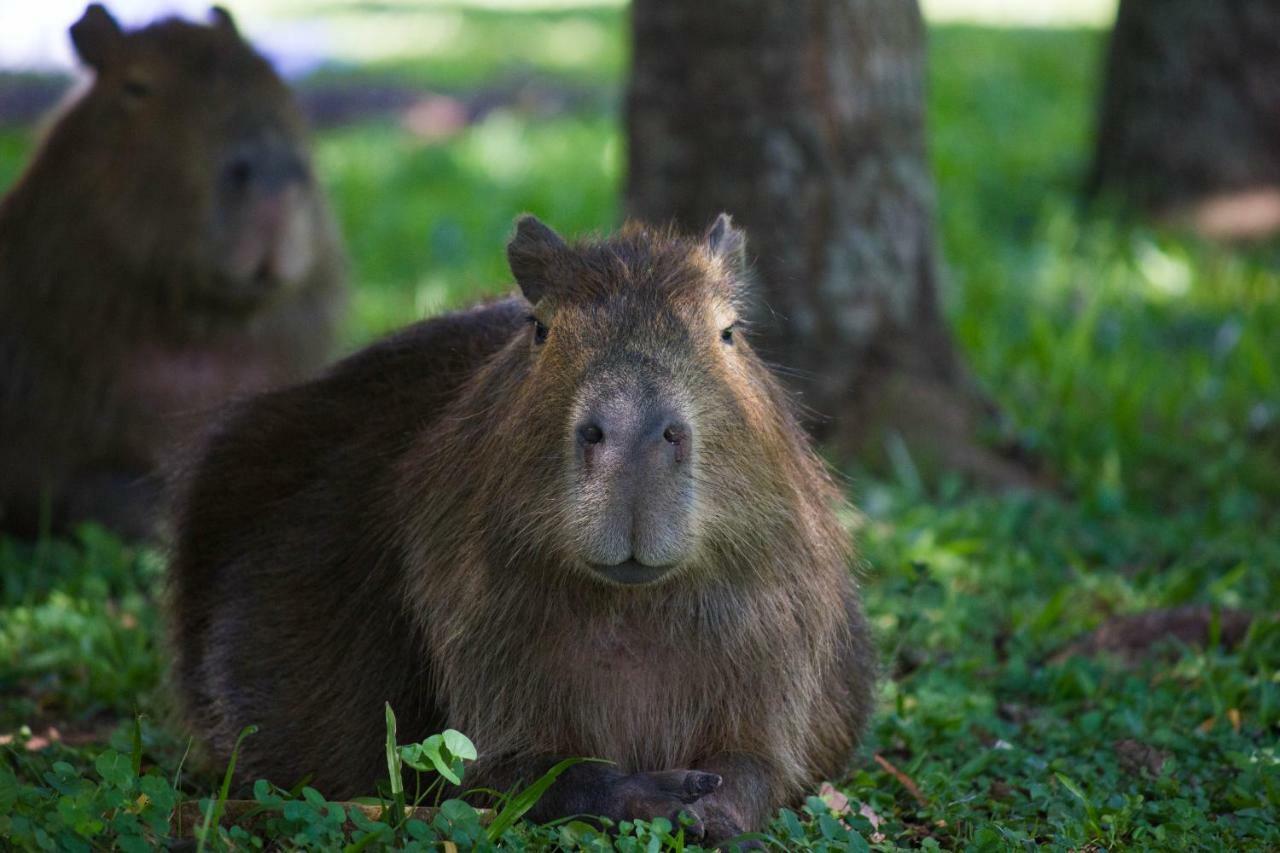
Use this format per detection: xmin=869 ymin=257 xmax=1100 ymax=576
xmin=317 ymin=111 xmax=621 ymax=342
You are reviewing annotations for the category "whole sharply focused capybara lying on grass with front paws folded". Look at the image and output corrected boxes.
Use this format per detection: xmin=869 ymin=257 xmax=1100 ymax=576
xmin=172 ymin=215 xmax=874 ymax=840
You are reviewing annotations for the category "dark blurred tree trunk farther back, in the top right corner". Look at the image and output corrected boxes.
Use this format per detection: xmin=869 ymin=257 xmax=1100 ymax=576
xmin=1089 ymin=0 xmax=1280 ymax=237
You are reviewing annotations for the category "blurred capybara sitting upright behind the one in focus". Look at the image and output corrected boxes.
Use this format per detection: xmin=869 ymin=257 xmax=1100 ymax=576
xmin=0 ymin=5 xmax=344 ymax=535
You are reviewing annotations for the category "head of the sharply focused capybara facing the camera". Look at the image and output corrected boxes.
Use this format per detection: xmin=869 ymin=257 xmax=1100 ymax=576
xmin=499 ymin=215 xmax=808 ymax=584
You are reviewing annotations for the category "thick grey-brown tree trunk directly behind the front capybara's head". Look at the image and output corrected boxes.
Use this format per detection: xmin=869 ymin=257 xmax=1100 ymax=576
xmin=627 ymin=0 xmax=1025 ymax=484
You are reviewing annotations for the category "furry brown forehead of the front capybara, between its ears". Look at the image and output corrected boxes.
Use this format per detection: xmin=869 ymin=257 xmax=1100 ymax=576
xmin=552 ymin=223 xmax=737 ymax=311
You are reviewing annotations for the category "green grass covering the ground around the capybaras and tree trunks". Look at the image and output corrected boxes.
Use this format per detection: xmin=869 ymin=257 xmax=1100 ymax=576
xmin=0 ymin=10 xmax=1280 ymax=850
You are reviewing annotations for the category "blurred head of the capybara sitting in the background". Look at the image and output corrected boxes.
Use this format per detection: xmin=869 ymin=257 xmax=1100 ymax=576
xmin=64 ymin=4 xmax=324 ymax=305
